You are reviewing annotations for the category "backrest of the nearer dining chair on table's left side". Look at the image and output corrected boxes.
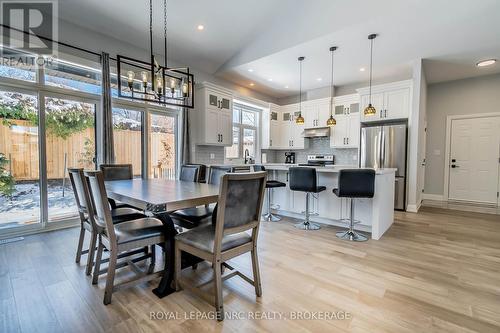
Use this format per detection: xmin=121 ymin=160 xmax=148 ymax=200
xmin=84 ymin=171 xmax=116 ymax=236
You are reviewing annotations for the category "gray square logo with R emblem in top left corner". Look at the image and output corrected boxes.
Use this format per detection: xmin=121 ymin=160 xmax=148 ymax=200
xmin=0 ymin=0 xmax=58 ymax=56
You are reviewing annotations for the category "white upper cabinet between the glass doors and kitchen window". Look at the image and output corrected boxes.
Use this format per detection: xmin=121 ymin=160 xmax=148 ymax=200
xmin=189 ymin=83 xmax=233 ymax=147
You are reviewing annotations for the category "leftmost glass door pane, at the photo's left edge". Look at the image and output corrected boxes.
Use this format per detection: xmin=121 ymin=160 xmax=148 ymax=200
xmin=0 ymin=90 xmax=41 ymax=231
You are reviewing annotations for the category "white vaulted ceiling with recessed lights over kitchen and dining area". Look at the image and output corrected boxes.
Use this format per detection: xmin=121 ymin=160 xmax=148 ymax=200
xmin=59 ymin=0 xmax=500 ymax=97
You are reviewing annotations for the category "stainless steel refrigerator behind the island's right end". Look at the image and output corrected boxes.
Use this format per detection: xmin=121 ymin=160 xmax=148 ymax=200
xmin=360 ymin=124 xmax=407 ymax=210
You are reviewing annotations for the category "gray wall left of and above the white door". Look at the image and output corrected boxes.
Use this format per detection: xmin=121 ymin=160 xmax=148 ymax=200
xmin=425 ymin=74 xmax=500 ymax=196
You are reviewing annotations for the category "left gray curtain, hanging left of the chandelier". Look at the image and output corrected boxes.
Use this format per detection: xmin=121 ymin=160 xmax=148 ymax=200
xmin=101 ymin=52 xmax=115 ymax=164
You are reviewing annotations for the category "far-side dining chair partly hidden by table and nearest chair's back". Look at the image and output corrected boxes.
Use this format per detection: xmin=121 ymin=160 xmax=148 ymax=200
xmin=171 ymin=166 xmax=232 ymax=229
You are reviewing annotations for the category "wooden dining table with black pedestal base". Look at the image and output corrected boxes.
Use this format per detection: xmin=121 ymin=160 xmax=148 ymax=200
xmin=106 ymin=179 xmax=219 ymax=298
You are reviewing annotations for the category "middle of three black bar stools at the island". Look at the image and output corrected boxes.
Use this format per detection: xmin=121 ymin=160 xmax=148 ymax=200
xmin=288 ymin=167 xmax=326 ymax=230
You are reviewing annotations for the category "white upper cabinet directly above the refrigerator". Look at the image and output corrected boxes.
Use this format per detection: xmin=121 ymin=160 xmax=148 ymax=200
xmin=358 ymin=80 xmax=412 ymax=122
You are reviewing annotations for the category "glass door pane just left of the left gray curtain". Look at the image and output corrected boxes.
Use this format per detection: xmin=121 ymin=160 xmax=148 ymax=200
xmin=44 ymin=96 xmax=97 ymax=222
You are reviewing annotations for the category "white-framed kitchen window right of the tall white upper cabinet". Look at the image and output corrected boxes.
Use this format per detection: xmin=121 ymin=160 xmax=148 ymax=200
xmin=225 ymin=102 xmax=261 ymax=159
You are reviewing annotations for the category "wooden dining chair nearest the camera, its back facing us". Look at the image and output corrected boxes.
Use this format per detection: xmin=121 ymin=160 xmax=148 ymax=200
xmin=174 ymin=172 xmax=267 ymax=321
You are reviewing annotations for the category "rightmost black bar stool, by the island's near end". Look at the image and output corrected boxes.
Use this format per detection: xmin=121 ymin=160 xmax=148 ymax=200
xmin=333 ymin=169 xmax=375 ymax=242
